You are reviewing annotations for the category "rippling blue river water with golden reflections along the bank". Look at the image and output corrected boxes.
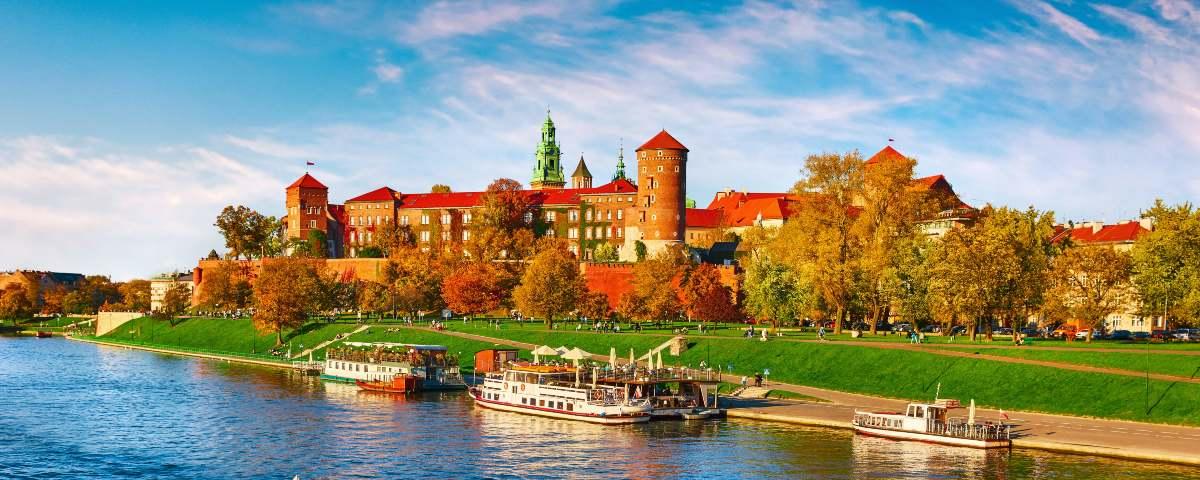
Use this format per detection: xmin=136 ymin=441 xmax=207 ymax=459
xmin=0 ymin=337 xmax=1198 ymax=480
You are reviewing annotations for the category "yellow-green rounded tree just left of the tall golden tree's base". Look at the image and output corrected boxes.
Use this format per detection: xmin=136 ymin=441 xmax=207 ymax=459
xmin=743 ymin=253 xmax=816 ymax=324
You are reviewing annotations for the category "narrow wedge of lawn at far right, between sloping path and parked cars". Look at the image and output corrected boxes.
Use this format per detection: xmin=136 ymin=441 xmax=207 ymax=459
xmin=947 ymin=347 xmax=1200 ymax=377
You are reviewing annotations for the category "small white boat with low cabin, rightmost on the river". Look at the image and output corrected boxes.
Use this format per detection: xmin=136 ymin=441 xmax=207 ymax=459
xmin=852 ymin=400 xmax=1013 ymax=449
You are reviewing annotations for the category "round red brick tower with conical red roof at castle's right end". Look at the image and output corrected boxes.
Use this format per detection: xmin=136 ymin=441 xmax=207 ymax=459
xmin=622 ymin=130 xmax=688 ymax=258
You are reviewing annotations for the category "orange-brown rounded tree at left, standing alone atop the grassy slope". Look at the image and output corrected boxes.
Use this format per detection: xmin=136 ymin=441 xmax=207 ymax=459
xmin=253 ymin=257 xmax=320 ymax=346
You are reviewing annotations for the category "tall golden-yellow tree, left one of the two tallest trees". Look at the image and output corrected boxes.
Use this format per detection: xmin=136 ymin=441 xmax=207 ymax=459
xmin=772 ymin=151 xmax=865 ymax=334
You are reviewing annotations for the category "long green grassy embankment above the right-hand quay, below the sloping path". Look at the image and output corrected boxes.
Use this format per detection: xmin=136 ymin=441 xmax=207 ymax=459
xmin=436 ymin=324 xmax=1200 ymax=425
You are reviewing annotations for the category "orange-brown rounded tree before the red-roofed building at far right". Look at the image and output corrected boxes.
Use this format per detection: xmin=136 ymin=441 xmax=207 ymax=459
xmin=1051 ymin=246 xmax=1133 ymax=342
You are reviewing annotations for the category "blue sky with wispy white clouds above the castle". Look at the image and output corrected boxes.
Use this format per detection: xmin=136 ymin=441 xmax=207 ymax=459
xmin=0 ymin=0 xmax=1200 ymax=280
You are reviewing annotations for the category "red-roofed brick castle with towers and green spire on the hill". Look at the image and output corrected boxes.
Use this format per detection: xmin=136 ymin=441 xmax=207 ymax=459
xmin=283 ymin=112 xmax=688 ymax=260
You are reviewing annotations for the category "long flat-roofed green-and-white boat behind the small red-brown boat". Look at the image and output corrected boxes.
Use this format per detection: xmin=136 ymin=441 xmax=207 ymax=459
xmin=320 ymin=342 xmax=467 ymax=390
